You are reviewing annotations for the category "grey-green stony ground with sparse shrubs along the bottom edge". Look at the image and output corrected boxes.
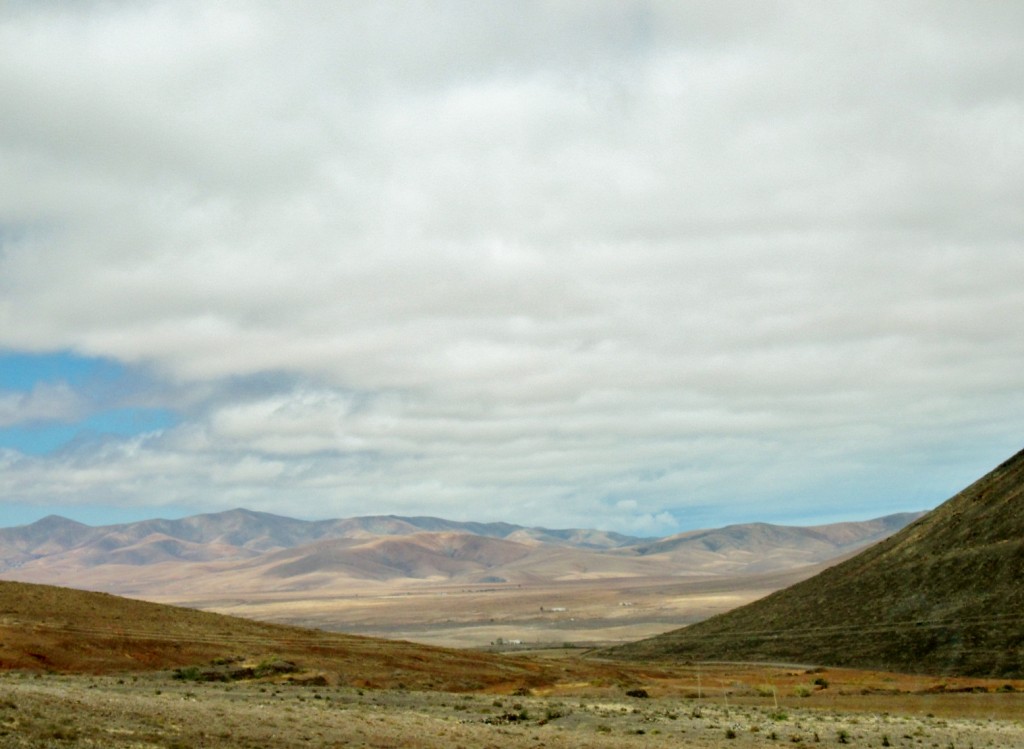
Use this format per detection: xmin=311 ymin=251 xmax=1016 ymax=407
xmin=0 ymin=672 xmax=1024 ymax=749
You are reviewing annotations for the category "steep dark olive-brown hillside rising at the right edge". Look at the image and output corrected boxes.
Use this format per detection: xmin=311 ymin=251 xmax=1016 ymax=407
xmin=609 ymin=451 xmax=1024 ymax=677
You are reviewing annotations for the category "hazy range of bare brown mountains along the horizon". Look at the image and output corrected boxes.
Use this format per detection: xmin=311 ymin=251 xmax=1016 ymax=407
xmin=0 ymin=509 xmax=914 ymax=597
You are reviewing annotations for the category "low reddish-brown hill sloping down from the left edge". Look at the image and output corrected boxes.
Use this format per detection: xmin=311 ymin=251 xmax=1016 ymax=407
xmin=0 ymin=582 xmax=663 ymax=692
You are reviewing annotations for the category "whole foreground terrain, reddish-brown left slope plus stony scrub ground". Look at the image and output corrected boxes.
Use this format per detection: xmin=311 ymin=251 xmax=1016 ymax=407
xmin=0 ymin=582 xmax=1024 ymax=749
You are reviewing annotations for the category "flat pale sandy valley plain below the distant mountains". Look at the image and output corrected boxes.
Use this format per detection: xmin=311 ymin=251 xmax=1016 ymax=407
xmin=159 ymin=566 xmax=806 ymax=650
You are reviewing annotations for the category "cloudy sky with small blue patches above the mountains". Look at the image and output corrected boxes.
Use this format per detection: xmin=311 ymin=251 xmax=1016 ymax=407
xmin=0 ymin=0 xmax=1024 ymax=536
